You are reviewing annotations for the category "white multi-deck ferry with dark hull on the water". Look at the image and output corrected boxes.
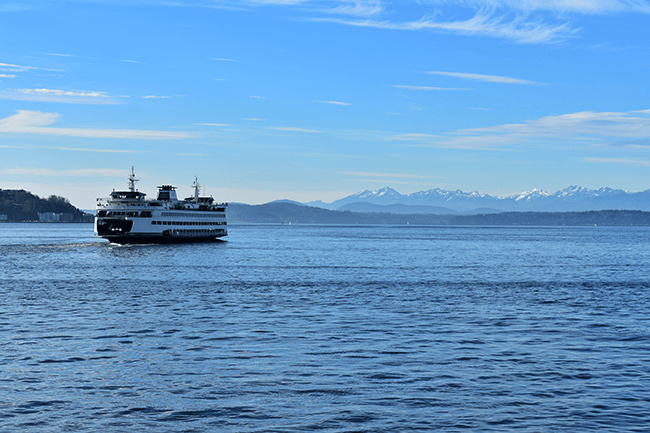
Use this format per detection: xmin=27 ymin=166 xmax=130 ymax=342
xmin=95 ymin=167 xmax=228 ymax=244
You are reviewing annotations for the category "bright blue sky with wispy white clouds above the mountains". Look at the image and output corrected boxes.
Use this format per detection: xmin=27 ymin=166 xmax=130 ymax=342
xmin=0 ymin=0 xmax=650 ymax=209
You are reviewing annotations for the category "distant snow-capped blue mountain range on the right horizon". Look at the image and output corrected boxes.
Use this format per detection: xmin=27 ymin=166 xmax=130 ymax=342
xmin=305 ymin=186 xmax=650 ymax=214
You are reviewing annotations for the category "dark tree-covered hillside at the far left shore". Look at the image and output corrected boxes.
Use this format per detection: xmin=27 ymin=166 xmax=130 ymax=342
xmin=0 ymin=189 xmax=84 ymax=222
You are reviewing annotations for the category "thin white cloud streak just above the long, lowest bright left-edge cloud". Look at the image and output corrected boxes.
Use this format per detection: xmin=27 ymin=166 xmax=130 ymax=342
xmin=0 ymin=88 xmax=119 ymax=105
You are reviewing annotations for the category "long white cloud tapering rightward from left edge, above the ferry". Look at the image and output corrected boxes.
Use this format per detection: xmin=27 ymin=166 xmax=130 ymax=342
xmin=0 ymin=110 xmax=192 ymax=138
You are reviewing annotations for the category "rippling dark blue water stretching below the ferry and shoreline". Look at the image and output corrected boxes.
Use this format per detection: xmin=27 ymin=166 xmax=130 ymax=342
xmin=0 ymin=224 xmax=650 ymax=432
